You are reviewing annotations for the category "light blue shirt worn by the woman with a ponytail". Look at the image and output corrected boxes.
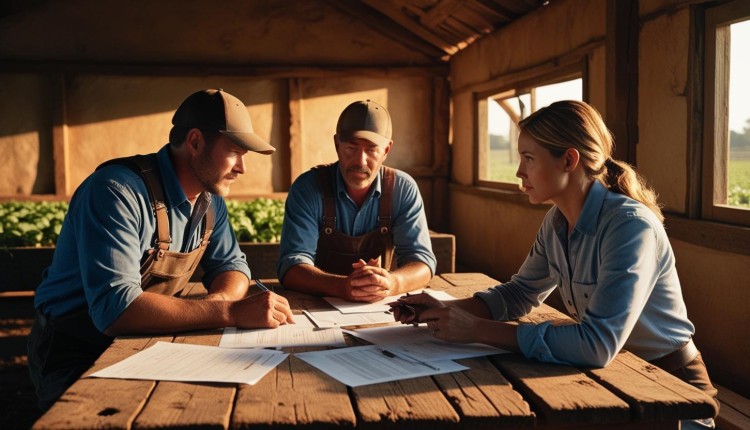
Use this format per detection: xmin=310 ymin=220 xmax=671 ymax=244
xmin=475 ymin=181 xmax=695 ymax=367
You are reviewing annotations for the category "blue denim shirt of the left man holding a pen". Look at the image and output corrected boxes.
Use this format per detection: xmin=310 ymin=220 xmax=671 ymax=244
xmin=34 ymin=145 xmax=250 ymax=331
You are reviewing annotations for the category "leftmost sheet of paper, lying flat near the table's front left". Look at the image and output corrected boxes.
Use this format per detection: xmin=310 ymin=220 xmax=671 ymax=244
xmin=89 ymin=342 xmax=288 ymax=385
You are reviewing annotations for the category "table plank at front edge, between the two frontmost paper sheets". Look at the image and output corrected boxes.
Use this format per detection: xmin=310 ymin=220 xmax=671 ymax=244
xmin=232 ymin=348 xmax=356 ymax=429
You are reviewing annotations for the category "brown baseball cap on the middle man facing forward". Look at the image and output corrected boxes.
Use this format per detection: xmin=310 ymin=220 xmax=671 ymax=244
xmin=336 ymin=100 xmax=393 ymax=146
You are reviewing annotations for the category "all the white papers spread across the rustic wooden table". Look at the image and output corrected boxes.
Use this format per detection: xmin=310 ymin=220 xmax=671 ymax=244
xmin=89 ymin=290 xmax=506 ymax=387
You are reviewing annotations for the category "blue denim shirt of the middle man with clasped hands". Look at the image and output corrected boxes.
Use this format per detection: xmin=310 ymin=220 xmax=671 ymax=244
xmin=276 ymin=163 xmax=437 ymax=280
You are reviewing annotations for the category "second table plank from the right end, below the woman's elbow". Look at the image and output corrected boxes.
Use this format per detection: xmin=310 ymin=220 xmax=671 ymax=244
xmin=490 ymin=354 xmax=630 ymax=425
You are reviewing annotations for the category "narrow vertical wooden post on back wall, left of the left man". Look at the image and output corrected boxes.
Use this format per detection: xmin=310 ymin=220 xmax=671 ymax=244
xmin=52 ymin=75 xmax=71 ymax=199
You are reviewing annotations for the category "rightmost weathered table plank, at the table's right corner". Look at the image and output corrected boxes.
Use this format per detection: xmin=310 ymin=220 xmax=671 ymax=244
xmin=585 ymin=352 xmax=717 ymax=421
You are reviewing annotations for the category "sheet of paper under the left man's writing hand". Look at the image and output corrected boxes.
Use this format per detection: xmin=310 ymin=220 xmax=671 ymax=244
xmin=219 ymin=326 xmax=346 ymax=348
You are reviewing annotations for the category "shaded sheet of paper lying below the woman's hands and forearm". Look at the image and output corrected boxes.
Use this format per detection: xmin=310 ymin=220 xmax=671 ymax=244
xmin=345 ymin=324 xmax=508 ymax=361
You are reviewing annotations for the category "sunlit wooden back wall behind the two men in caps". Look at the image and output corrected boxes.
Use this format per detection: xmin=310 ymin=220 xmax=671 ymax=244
xmin=0 ymin=0 xmax=449 ymax=230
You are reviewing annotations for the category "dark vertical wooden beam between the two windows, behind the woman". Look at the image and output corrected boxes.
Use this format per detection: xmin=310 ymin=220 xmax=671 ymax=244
xmin=605 ymin=0 xmax=638 ymax=166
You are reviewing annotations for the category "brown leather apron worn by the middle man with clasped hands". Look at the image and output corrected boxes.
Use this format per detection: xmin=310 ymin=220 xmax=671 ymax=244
xmin=314 ymin=164 xmax=396 ymax=275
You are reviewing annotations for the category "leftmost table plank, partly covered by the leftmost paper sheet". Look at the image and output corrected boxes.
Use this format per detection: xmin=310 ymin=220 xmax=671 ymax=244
xmin=33 ymin=336 xmax=172 ymax=429
